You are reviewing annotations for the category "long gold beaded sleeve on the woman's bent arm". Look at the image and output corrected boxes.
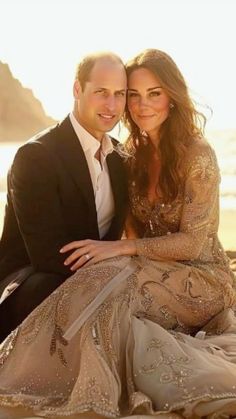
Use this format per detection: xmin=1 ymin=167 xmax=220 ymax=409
xmin=136 ymin=142 xmax=220 ymax=260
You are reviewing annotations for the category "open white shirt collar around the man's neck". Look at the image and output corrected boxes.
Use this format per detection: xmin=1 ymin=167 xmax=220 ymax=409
xmin=69 ymin=112 xmax=114 ymax=157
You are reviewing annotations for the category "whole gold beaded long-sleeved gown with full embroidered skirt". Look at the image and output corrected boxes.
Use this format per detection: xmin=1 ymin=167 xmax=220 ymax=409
xmin=0 ymin=140 xmax=236 ymax=419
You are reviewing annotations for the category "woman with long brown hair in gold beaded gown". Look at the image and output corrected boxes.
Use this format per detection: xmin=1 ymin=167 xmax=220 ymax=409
xmin=0 ymin=50 xmax=236 ymax=418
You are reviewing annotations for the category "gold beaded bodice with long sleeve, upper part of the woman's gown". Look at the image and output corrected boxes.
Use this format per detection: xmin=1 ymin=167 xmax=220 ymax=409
xmin=129 ymin=139 xmax=233 ymax=270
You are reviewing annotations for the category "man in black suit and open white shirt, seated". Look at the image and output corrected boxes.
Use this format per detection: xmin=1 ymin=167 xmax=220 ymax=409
xmin=0 ymin=53 xmax=127 ymax=340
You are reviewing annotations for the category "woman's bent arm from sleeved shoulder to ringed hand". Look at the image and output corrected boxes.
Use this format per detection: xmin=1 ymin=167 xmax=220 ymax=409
xmin=61 ymin=143 xmax=220 ymax=270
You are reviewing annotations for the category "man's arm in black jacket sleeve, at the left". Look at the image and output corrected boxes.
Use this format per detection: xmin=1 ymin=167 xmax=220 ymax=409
xmin=10 ymin=142 xmax=72 ymax=276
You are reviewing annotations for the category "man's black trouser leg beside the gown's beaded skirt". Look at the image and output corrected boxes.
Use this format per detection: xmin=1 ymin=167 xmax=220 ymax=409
xmin=0 ymin=272 xmax=65 ymax=342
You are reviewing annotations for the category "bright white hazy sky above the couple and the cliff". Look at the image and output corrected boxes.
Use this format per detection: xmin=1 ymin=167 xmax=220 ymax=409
xmin=0 ymin=0 xmax=236 ymax=129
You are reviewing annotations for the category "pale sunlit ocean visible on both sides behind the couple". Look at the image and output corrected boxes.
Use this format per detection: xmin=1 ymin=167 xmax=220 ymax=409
xmin=0 ymin=130 xmax=236 ymax=210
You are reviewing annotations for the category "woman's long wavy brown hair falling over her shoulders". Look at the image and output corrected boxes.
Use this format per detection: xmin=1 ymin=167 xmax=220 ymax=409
xmin=124 ymin=49 xmax=206 ymax=202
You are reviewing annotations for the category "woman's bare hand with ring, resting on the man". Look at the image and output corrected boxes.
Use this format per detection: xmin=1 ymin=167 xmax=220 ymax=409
xmin=60 ymin=240 xmax=136 ymax=271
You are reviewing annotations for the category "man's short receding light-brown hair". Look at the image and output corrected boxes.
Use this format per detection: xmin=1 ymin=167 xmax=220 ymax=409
xmin=75 ymin=52 xmax=124 ymax=90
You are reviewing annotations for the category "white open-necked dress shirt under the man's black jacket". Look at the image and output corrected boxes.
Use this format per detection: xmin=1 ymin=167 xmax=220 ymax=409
xmin=70 ymin=113 xmax=115 ymax=238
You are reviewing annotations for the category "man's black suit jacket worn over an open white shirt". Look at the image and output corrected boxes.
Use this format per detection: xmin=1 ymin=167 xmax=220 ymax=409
xmin=0 ymin=117 xmax=127 ymax=280
